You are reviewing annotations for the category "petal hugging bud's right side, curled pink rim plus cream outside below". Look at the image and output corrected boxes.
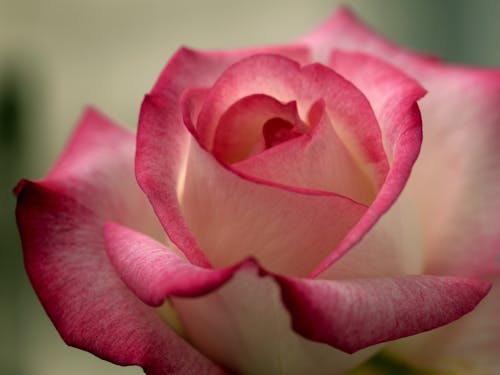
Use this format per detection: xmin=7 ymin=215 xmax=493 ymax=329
xmin=314 ymin=52 xmax=425 ymax=278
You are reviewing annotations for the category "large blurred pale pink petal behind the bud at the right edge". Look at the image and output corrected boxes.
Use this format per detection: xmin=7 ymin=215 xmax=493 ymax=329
xmin=302 ymin=10 xmax=500 ymax=371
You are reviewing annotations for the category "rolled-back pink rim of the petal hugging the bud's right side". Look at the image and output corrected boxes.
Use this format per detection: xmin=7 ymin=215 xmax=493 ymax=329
xmin=311 ymin=52 xmax=425 ymax=277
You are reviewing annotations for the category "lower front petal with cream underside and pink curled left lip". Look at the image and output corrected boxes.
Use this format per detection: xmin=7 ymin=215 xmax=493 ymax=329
xmin=106 ymin=223 xmax=376 ymax=375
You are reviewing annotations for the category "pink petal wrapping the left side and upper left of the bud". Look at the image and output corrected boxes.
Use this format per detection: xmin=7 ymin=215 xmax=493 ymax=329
xmin=136 ymin=47 xmax=308 ymax=266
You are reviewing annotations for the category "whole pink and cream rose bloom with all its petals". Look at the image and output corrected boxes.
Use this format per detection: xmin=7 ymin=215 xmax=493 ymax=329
xmin=16 ymin=9 xmax=500 ymax=375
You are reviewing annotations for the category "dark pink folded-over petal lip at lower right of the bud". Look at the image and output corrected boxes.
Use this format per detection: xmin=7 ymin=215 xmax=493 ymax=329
xmin=282 ymin=275 xmax=491 ymax=353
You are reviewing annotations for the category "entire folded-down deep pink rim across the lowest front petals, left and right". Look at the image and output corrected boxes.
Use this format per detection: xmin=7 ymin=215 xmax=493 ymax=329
xmin=106 ymin=224 xmax=491 ymax=353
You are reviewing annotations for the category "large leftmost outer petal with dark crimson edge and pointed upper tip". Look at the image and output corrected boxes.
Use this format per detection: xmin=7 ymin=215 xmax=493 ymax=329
xmin=16 ymin=110 xmax=223 ymax=374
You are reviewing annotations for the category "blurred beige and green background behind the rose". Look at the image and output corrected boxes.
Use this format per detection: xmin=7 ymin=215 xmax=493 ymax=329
xmin=0 ymin=0 xmax=500 ymax=375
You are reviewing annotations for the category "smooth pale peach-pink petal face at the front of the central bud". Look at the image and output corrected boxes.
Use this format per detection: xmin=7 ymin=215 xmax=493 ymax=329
xmin=180 ymin=116 xmax=366 ymax=275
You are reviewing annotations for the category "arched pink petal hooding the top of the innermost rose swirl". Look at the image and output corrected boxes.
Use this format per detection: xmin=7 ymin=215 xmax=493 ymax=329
xmin=197 ymin=55 xmax=387 ymax=189
